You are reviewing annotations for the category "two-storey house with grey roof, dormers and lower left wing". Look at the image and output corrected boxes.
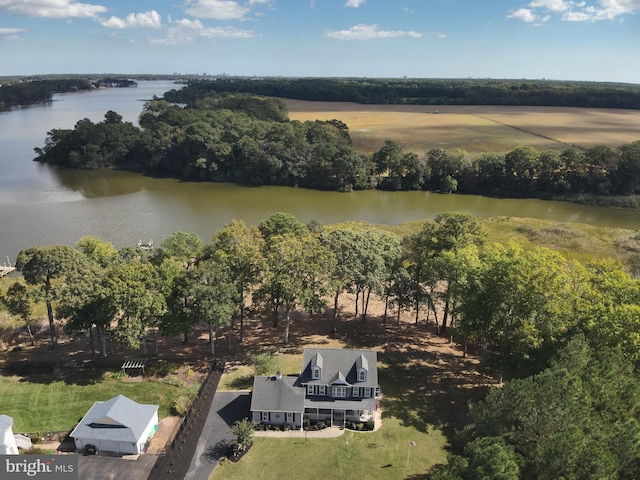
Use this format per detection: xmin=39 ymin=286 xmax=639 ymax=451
xmin=251 ymin=348 xmax=380 ymax=429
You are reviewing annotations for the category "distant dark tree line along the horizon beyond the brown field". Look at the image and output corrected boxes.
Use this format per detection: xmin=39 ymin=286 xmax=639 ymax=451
xmin=175 ymin=77 xmax=640 ymax=110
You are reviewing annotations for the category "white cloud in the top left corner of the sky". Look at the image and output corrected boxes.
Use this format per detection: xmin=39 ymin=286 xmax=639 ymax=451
xmin=0 ymin=0 xmax=107 ymax=18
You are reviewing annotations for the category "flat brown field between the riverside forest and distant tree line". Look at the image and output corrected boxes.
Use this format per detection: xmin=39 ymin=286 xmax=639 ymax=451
xmin=286 ymin=100 xmax=640 ymax=155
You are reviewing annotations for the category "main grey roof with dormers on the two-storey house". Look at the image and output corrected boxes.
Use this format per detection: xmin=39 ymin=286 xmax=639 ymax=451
xmin=299 ymin=348 xmax=378 ymax=387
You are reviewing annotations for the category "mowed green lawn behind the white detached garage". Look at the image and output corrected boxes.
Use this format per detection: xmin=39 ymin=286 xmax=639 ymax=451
xmin=0 ymin=371 xmax=182 ymax=433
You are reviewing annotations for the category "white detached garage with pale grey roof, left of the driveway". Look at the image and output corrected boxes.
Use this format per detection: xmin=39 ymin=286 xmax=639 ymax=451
xmin=71 ymin=395 xmax=158 ymax=455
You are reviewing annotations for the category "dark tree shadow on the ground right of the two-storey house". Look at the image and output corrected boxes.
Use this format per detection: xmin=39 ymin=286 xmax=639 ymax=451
xmin=341 ymin=316 xmax=489 ymax=441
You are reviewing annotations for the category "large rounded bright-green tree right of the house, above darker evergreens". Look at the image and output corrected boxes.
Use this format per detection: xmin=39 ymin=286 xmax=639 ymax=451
xmin=459 ymin=242 xmax=575 ymax=381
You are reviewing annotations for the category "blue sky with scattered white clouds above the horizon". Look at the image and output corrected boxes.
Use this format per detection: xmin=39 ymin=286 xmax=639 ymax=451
xmin=0 ymin=0 xmax=640 ymax=83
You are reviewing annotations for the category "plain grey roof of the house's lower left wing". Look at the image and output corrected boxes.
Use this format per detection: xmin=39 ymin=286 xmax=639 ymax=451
xmin=251 ymin=376 xmax=305 ymax=412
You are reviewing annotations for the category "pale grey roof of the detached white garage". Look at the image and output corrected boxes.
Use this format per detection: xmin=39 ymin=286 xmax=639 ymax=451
xmin=71 ymin=395 xmax=158 ymax=443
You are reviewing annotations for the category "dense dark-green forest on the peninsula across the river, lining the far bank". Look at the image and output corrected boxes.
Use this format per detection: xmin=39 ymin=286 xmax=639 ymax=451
xmin=36 ymin=84 xmax=640 ymax=201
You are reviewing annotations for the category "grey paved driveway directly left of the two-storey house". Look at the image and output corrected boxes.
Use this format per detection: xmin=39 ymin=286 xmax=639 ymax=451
xmin=184 ymin=391 xmax=251 ymax=480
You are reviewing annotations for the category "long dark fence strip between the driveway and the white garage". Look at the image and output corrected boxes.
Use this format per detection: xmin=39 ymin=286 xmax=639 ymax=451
xmin=147 ymin=361 xmax=224 ymax=480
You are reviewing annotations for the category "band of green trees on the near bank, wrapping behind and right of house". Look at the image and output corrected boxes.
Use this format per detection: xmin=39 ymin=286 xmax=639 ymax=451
xmin=0 ymin=212 xmax=640 ymax=480
